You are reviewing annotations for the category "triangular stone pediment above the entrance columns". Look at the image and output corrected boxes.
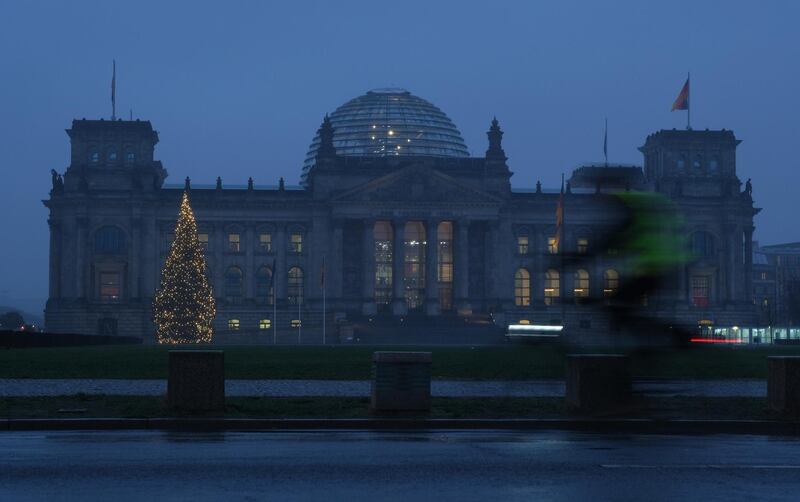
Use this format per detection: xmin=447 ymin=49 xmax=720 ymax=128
xmin=332 ymin=165 xmax=503 ymax=205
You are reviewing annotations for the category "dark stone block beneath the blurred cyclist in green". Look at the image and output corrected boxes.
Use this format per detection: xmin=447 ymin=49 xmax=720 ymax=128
xmin=565 ymin=354 xmax=631 ymax=412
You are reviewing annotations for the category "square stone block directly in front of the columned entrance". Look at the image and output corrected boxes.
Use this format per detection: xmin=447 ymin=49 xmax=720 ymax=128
xmin=370 ymin=352 xmax=432 ymax=412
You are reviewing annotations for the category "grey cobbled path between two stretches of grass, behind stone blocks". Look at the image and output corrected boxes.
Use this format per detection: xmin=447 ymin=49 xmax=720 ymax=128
xmin=0 ymin=379 xmax=767 ymax=397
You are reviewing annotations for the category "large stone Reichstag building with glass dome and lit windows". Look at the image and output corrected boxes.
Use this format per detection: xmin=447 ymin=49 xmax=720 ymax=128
xmin=44 ymin=89 xmax=758 ymax=343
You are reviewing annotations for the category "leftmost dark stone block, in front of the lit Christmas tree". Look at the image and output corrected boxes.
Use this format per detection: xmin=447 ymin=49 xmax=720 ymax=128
xmin=167 ymin=350 xmax=225 ymax=412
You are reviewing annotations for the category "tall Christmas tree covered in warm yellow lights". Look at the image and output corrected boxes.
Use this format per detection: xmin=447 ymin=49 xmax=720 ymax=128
xmin=153 ymin=192 xmax=216 ymax=343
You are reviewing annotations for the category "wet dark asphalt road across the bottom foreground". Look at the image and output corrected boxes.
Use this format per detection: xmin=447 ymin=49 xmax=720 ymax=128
xmin=0 ymin=431 xmax=800 ymax=502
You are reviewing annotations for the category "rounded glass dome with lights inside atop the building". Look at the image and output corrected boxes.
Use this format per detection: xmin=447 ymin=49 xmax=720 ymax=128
xmin=302 ymin=89 xmax=469 ymax=180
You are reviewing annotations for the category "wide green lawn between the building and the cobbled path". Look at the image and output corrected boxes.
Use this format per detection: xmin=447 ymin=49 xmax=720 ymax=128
xmin=0 ymin=345 xmax=800 ymax=380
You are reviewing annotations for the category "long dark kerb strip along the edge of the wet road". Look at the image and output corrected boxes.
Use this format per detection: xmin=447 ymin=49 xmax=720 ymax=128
xmin=0 ymin=418 xmax=800 ymax=436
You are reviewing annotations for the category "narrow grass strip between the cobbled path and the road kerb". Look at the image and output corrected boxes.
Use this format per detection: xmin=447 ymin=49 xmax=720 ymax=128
xmin=0 ymin=394 xmax=775 ymax=420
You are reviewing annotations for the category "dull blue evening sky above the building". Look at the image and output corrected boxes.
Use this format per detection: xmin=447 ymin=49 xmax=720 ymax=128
xmin=0 ymin=0 xmax=800 ymax=311
